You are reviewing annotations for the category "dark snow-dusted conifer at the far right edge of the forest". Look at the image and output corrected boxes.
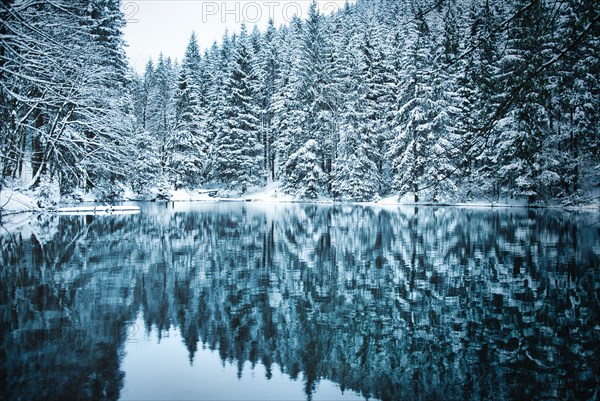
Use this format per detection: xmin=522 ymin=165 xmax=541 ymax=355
xmin=545 ymin=0 xmax=600 ymax=200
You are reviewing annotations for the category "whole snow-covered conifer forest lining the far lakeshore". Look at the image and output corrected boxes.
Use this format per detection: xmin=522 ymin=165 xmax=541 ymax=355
xmin=0 ymin=0 xmax=600 ymax=203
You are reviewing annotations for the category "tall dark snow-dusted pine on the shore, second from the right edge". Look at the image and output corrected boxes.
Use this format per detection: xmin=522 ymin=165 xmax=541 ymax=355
xmin=497 ymin=0 xmax=558 ymax=202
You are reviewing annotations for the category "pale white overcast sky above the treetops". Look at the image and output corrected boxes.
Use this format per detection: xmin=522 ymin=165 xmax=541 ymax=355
xmin=122 ymin=0 xmax=345 ymax=72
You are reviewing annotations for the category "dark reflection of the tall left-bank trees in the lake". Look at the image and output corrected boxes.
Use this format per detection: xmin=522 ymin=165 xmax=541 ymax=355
xmin=0 ymin=217 xmax=135 ymax=399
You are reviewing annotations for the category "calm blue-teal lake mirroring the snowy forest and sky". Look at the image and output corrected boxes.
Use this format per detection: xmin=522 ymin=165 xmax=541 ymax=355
xmin=0 ymin=203 xmax=600 ymax=400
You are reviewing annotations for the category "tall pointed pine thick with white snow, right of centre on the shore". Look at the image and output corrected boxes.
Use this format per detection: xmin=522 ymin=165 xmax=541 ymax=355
xmin=387 ymin=8 xmax=448 ymax=202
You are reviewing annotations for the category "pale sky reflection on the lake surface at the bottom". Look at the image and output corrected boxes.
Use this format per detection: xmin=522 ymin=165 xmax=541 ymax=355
xmin=121 ymin=314 xmax=364 ymax=401
